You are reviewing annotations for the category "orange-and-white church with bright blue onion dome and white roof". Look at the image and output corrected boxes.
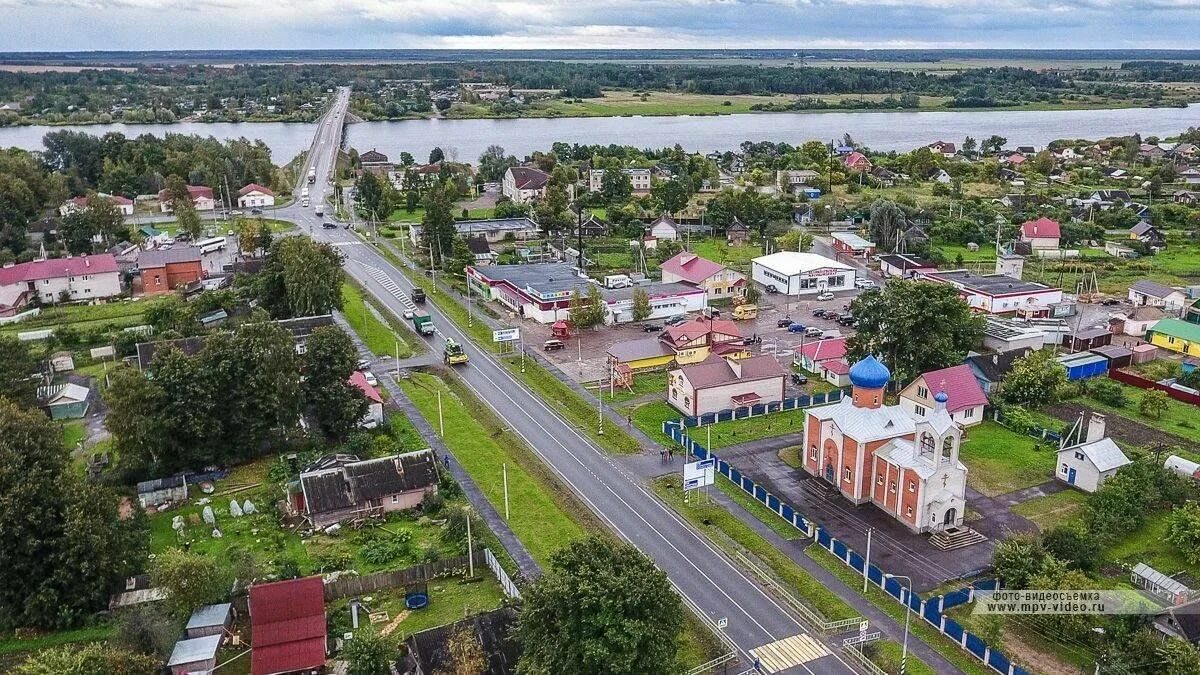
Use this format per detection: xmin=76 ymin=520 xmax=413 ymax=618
xmin=803 ymin=354 xmax=967 ymax=532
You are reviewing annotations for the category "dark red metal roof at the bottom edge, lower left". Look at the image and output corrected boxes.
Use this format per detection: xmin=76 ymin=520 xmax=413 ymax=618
xmin=250 ymin=577 xmax=325 ymax=675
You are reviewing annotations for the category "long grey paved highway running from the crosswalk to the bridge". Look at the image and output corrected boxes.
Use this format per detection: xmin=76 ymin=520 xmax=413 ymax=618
xmin=292 ymin=89 xmax=873 ymax=674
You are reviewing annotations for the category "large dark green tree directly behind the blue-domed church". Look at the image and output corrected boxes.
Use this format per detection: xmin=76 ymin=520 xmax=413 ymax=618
xmin=846 ymin=280 xmax=983 ymax=383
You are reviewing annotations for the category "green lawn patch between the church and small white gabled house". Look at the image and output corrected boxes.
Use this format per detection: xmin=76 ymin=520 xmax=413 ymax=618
xmin=960 ymin=420 xmax=1056 ymax=497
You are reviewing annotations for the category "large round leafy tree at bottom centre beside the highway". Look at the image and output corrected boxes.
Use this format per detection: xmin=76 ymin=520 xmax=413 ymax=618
xmin=516 ymin=537 xmax=683 ymax=674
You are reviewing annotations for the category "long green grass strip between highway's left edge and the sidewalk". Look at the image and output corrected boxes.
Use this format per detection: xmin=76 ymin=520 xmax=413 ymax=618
xmin=401 ymin=374 xmax=594 ymax=565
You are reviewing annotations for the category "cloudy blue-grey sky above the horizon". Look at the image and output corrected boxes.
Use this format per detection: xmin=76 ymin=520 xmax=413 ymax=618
xmin=0 ymin=0 xmax=1200 ymax=50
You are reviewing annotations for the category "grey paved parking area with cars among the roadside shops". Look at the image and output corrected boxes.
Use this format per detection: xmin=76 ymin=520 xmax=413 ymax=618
xmin=513 ymin=283 xmax=859 ymax=382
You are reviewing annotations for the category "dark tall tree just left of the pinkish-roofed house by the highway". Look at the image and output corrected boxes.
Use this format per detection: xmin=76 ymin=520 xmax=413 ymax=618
xmin=301 ymin=325 xmax=367 ymax=441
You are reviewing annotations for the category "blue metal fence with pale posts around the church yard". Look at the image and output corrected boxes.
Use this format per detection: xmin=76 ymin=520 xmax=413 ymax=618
xmin=662 ymin=417 xmax=1030 ymax=675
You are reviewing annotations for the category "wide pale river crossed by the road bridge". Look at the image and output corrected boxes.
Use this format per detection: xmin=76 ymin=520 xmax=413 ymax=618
xmin=0 ymin=104 xmax=1200 ymax=163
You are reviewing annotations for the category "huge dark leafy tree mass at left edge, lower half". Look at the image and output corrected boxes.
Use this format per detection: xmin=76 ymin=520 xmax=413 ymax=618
xmin=0 ymin=399 xmax=145 ymax=629
